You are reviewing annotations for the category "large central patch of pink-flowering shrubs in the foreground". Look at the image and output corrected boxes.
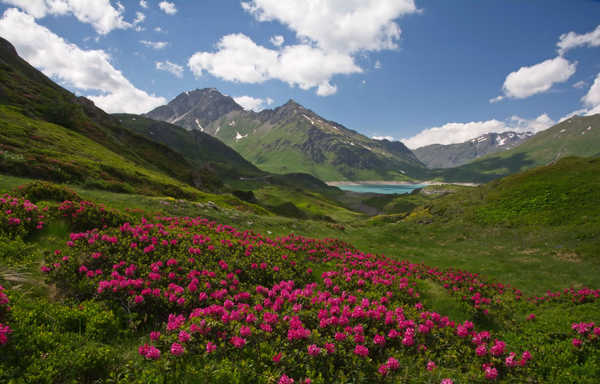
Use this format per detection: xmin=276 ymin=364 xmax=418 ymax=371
xmin=42 ymin=217 xmax=532 ymax=382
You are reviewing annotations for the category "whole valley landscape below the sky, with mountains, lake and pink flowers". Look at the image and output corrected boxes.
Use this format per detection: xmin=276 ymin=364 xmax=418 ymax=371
xmin=0 ymin=28 xmax=600 ymax=384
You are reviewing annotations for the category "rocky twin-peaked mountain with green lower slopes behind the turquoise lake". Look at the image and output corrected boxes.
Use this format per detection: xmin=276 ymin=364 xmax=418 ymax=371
xmin=146 ymin=88 xmax=426 ymax=180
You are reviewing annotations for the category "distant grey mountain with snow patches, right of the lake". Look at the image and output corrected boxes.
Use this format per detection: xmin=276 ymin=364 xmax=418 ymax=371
xmin=413 ymin=132 xmax=533 ymax=168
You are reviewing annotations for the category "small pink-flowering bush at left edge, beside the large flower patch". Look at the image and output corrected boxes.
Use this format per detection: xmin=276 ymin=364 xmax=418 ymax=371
xmin=0 ymin=194 xmax=48 ymax=237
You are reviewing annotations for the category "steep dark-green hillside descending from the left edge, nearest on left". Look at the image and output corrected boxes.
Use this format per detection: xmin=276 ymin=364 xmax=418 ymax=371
xmin=0 ymin=38 xmax=219 ymax=196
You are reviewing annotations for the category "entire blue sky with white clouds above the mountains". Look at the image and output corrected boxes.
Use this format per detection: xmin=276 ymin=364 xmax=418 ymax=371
xmin=0 ymin=0 xmax=600 ymax=148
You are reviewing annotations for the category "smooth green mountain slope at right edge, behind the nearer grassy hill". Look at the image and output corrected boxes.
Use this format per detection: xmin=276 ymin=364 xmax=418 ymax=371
xmin=432 ymin=114 xmax=600 ymax=182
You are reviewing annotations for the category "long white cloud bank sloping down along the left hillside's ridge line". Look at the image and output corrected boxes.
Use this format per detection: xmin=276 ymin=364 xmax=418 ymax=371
xmin=0 ymin=8 xmax=166 ymax=113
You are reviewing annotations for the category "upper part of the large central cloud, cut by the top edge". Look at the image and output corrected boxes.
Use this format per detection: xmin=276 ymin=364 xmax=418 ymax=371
xmin=242 ymin=0 xmax=418 ymax=53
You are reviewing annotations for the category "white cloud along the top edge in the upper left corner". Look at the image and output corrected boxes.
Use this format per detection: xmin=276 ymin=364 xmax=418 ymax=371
xmin=1 ymin=0 xmax=132 ymax=35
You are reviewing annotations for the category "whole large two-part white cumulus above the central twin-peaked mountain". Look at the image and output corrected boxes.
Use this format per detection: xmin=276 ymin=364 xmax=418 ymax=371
xmin=188 ymin=0 xmax=418 ymax=96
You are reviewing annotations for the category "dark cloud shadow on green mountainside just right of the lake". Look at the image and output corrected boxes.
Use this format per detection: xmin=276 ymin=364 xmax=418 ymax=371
xmin=431 ymin=153 xmax=535 ymax=183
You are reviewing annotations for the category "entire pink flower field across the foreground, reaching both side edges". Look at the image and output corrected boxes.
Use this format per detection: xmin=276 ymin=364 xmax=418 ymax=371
xmin=0 ymin=185 xmax=600 ymax=384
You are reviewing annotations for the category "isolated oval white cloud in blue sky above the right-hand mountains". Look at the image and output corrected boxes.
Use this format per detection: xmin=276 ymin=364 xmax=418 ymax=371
xmin=503 ymin=56 xmax=577 ymax=99
